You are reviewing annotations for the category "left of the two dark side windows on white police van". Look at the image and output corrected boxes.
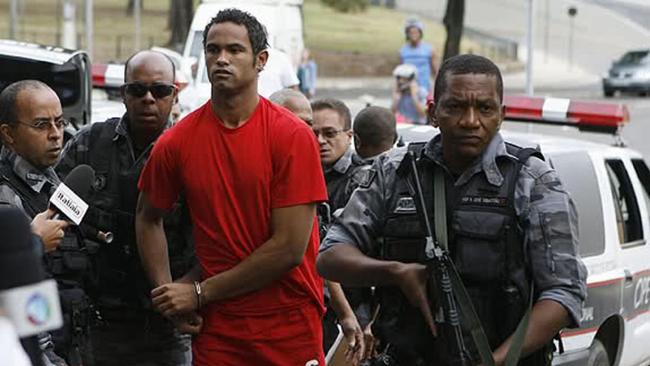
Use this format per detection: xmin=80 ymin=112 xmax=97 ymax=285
xmin=605 ymin=159 xmax=643 ymax=245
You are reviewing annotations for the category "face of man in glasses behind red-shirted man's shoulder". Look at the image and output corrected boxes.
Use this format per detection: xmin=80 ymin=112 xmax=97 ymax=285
xmin=312 ymin=108 xmax=352 ymax=167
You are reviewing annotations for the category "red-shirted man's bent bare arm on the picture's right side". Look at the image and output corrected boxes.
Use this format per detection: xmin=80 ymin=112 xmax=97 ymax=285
xmin=201 ymin=203 xmax=316 ymax=303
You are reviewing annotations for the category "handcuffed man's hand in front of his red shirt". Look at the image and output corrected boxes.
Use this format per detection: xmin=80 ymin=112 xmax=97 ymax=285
xmin=151 ymin=283 xmax=198 ymax=318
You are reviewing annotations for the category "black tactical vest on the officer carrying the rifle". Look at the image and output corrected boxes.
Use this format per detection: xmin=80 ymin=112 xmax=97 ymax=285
xmin=376 ymin=144 xmax=552 ymax=365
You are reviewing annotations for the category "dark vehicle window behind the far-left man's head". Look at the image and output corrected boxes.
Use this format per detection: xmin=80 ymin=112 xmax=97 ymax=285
xmin=0 ymin=58 xmax=82 ymax=107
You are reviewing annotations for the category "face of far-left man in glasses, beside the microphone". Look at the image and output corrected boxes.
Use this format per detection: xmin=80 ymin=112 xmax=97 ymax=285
xmin=2 ymin=88 xmax=63 ymax=170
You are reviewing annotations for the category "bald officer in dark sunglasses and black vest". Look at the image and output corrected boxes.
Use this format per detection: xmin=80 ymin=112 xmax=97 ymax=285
xmin=57 ymin=51 xmax=193 ymax=366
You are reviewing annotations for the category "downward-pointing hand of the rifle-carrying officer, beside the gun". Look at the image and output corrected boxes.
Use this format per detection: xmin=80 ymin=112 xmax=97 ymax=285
xmin=396 ymin=263 xmax=438 ymax=336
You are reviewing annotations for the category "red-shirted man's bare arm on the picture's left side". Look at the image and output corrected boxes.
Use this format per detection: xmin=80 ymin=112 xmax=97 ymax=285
xmin=135 ymin=192 xmax=172 ymax=287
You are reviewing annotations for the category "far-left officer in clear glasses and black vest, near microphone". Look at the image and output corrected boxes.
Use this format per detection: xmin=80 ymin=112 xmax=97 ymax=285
xmin=0 ymin=80 xmax=92 ymax=366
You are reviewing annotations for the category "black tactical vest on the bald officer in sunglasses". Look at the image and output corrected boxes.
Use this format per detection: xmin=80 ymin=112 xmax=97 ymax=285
xmin=85 ymin=118 xmax=193 ymax=308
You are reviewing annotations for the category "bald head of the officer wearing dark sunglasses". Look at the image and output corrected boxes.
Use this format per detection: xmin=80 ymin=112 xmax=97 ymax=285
xmin=122 ymin=52 xmax=176 ymax=133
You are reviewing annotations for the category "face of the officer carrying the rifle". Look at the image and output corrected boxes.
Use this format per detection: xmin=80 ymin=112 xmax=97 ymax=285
xmin=432 ymin=74 xmax=503 ymax=172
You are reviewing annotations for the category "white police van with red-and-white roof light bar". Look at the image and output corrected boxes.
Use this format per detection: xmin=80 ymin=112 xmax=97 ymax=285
xmin=398 ymin=96 xmax=650 ymax=366
